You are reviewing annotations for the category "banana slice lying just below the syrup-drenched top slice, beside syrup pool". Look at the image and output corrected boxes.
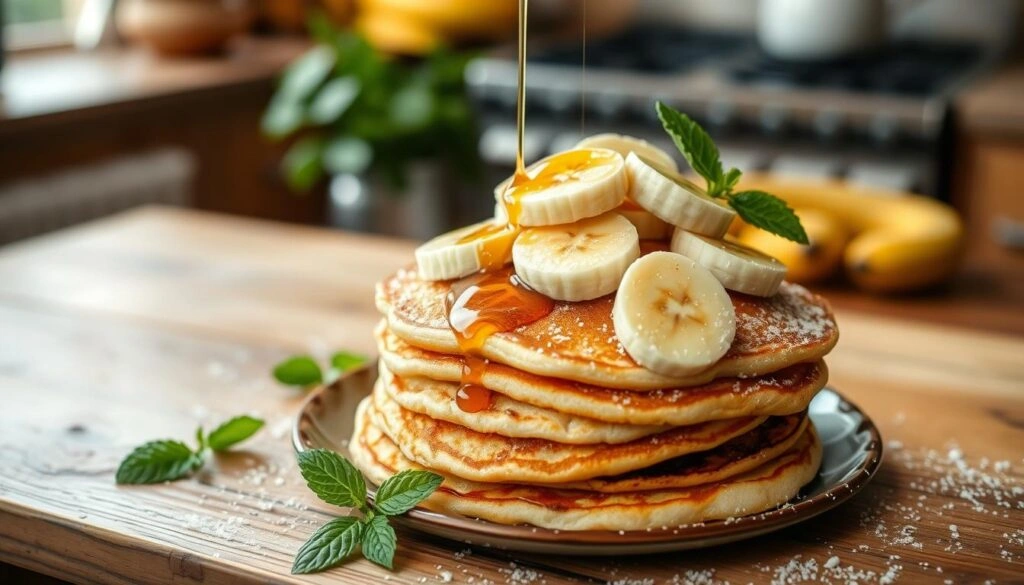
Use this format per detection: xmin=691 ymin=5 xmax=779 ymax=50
xmin=512 ymin=213 xmax=640 ymax=301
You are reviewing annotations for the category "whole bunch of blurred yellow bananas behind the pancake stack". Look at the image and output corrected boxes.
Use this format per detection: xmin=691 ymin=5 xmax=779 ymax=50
xmin=730 ymin=175 xmax=964 ymax=293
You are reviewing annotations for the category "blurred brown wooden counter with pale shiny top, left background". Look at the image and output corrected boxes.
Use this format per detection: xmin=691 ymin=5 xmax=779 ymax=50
xmin=0 ymin=38 xmax=325 ymax=228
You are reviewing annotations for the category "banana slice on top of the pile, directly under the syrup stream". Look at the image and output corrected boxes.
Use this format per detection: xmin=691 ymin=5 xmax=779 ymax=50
xmin=495 ymin=149 xmax=629 ymax=226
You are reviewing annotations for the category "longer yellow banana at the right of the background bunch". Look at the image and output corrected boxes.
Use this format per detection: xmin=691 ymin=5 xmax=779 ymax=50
xmin=739 ymin=175 xmax=964 ymax=293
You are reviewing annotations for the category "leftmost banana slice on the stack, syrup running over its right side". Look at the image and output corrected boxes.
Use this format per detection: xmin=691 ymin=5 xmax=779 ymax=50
xmin=416 ymin=219 xmax=518 ymax=281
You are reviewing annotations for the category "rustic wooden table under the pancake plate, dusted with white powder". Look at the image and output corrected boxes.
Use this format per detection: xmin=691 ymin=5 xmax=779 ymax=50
xmin=0 ymin=209 xmax=1024 ymax=585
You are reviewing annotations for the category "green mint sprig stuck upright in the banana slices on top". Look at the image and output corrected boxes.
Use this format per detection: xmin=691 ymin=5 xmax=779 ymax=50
xmin=656 ymin=101 xmax=808 ymax=244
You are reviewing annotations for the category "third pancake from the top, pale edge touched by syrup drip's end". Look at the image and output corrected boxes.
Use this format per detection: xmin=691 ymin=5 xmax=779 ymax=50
xmin=380 ymin=362 xmax=670 ymax=445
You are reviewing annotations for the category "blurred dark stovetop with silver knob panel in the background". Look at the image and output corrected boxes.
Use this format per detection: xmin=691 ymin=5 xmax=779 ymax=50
xmin=467 ymin=25 xmax=988 ymax=141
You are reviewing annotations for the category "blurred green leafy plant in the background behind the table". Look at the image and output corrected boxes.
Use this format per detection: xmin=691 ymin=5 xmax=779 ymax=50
xmin=262 ymin=17 xmax=479 ymax=191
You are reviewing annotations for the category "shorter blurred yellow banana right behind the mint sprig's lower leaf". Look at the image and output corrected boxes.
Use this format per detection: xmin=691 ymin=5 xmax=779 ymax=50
xmin=736 ymin=208 xmax=850 ymax=284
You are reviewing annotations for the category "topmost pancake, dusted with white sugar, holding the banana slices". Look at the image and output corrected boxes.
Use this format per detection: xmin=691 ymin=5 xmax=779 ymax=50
xmin=377 ymin=269 xmax=839 ymax=390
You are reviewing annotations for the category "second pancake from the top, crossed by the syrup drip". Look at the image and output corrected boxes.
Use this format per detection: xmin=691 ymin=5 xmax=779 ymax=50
xmin=377 ymin=324 xmax=828 ymax=426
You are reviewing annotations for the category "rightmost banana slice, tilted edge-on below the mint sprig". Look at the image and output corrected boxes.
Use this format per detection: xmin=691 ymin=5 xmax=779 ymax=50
xmin=672 ymin=229 xmax=785 ymax=296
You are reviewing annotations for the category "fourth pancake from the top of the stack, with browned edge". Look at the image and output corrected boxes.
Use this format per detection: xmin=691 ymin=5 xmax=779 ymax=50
xmin=370 ymin=383 xmax=767 ymax=484
